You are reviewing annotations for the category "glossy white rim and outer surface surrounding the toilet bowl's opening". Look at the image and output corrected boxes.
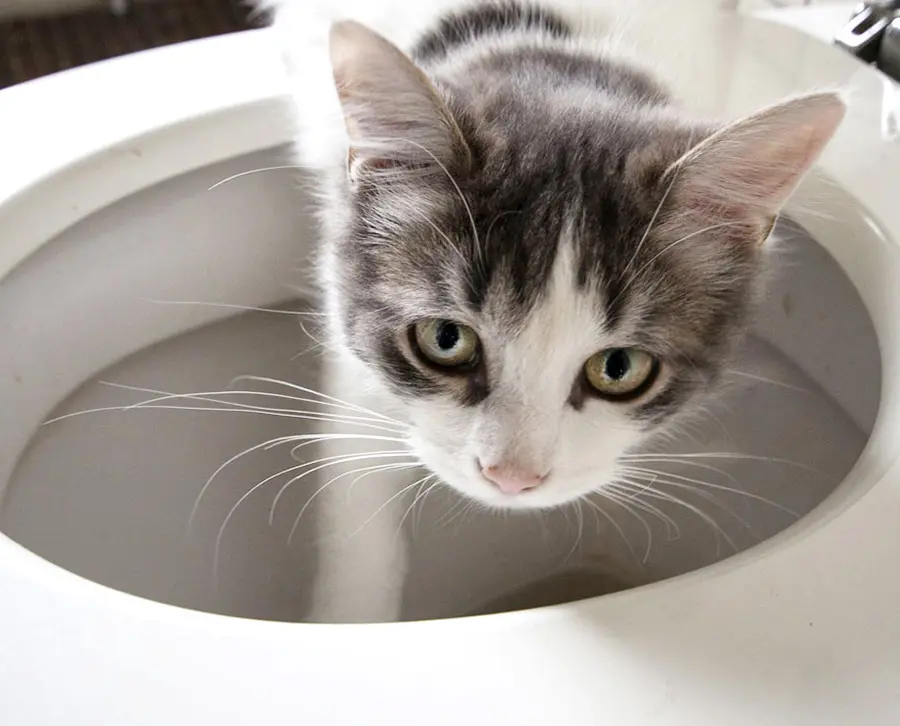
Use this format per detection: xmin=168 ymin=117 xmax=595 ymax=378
xmin=0 ymin=18 xmax=900 ymax=726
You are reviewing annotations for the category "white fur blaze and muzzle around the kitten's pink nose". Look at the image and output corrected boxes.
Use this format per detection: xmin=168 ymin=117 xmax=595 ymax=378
xmin=410 ymin=238 xmax=644 ymax=509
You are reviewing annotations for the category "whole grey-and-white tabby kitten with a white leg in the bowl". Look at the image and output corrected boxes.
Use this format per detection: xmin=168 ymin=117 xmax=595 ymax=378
xmin=263 ymin=0 xmax=845 ymax=622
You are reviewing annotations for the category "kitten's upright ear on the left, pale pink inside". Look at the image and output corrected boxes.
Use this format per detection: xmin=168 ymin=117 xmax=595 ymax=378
xmin=329 ymin=21 xmax=469 ymax=180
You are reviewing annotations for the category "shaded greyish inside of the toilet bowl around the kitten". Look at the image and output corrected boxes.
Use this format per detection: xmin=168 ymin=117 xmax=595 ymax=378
xmin=0 ymin=151 xmax=880 ymax=621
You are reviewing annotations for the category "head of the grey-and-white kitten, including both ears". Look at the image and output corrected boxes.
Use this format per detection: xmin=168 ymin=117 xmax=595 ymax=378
xmin=327 ymin=23 xmax=844 ymax=508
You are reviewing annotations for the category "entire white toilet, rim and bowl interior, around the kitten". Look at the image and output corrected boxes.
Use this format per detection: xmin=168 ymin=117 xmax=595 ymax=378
xmin=0 ymin=9 xmax=900 ymax=726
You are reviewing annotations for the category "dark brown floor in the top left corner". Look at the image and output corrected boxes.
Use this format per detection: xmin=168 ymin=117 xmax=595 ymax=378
xmin=0 ymin=0 xmax=263 ymax=88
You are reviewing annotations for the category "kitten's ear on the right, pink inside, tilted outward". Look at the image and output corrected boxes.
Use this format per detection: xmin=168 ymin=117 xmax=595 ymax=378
xmin=666 ymin=93 xmax=846 ymax=243
